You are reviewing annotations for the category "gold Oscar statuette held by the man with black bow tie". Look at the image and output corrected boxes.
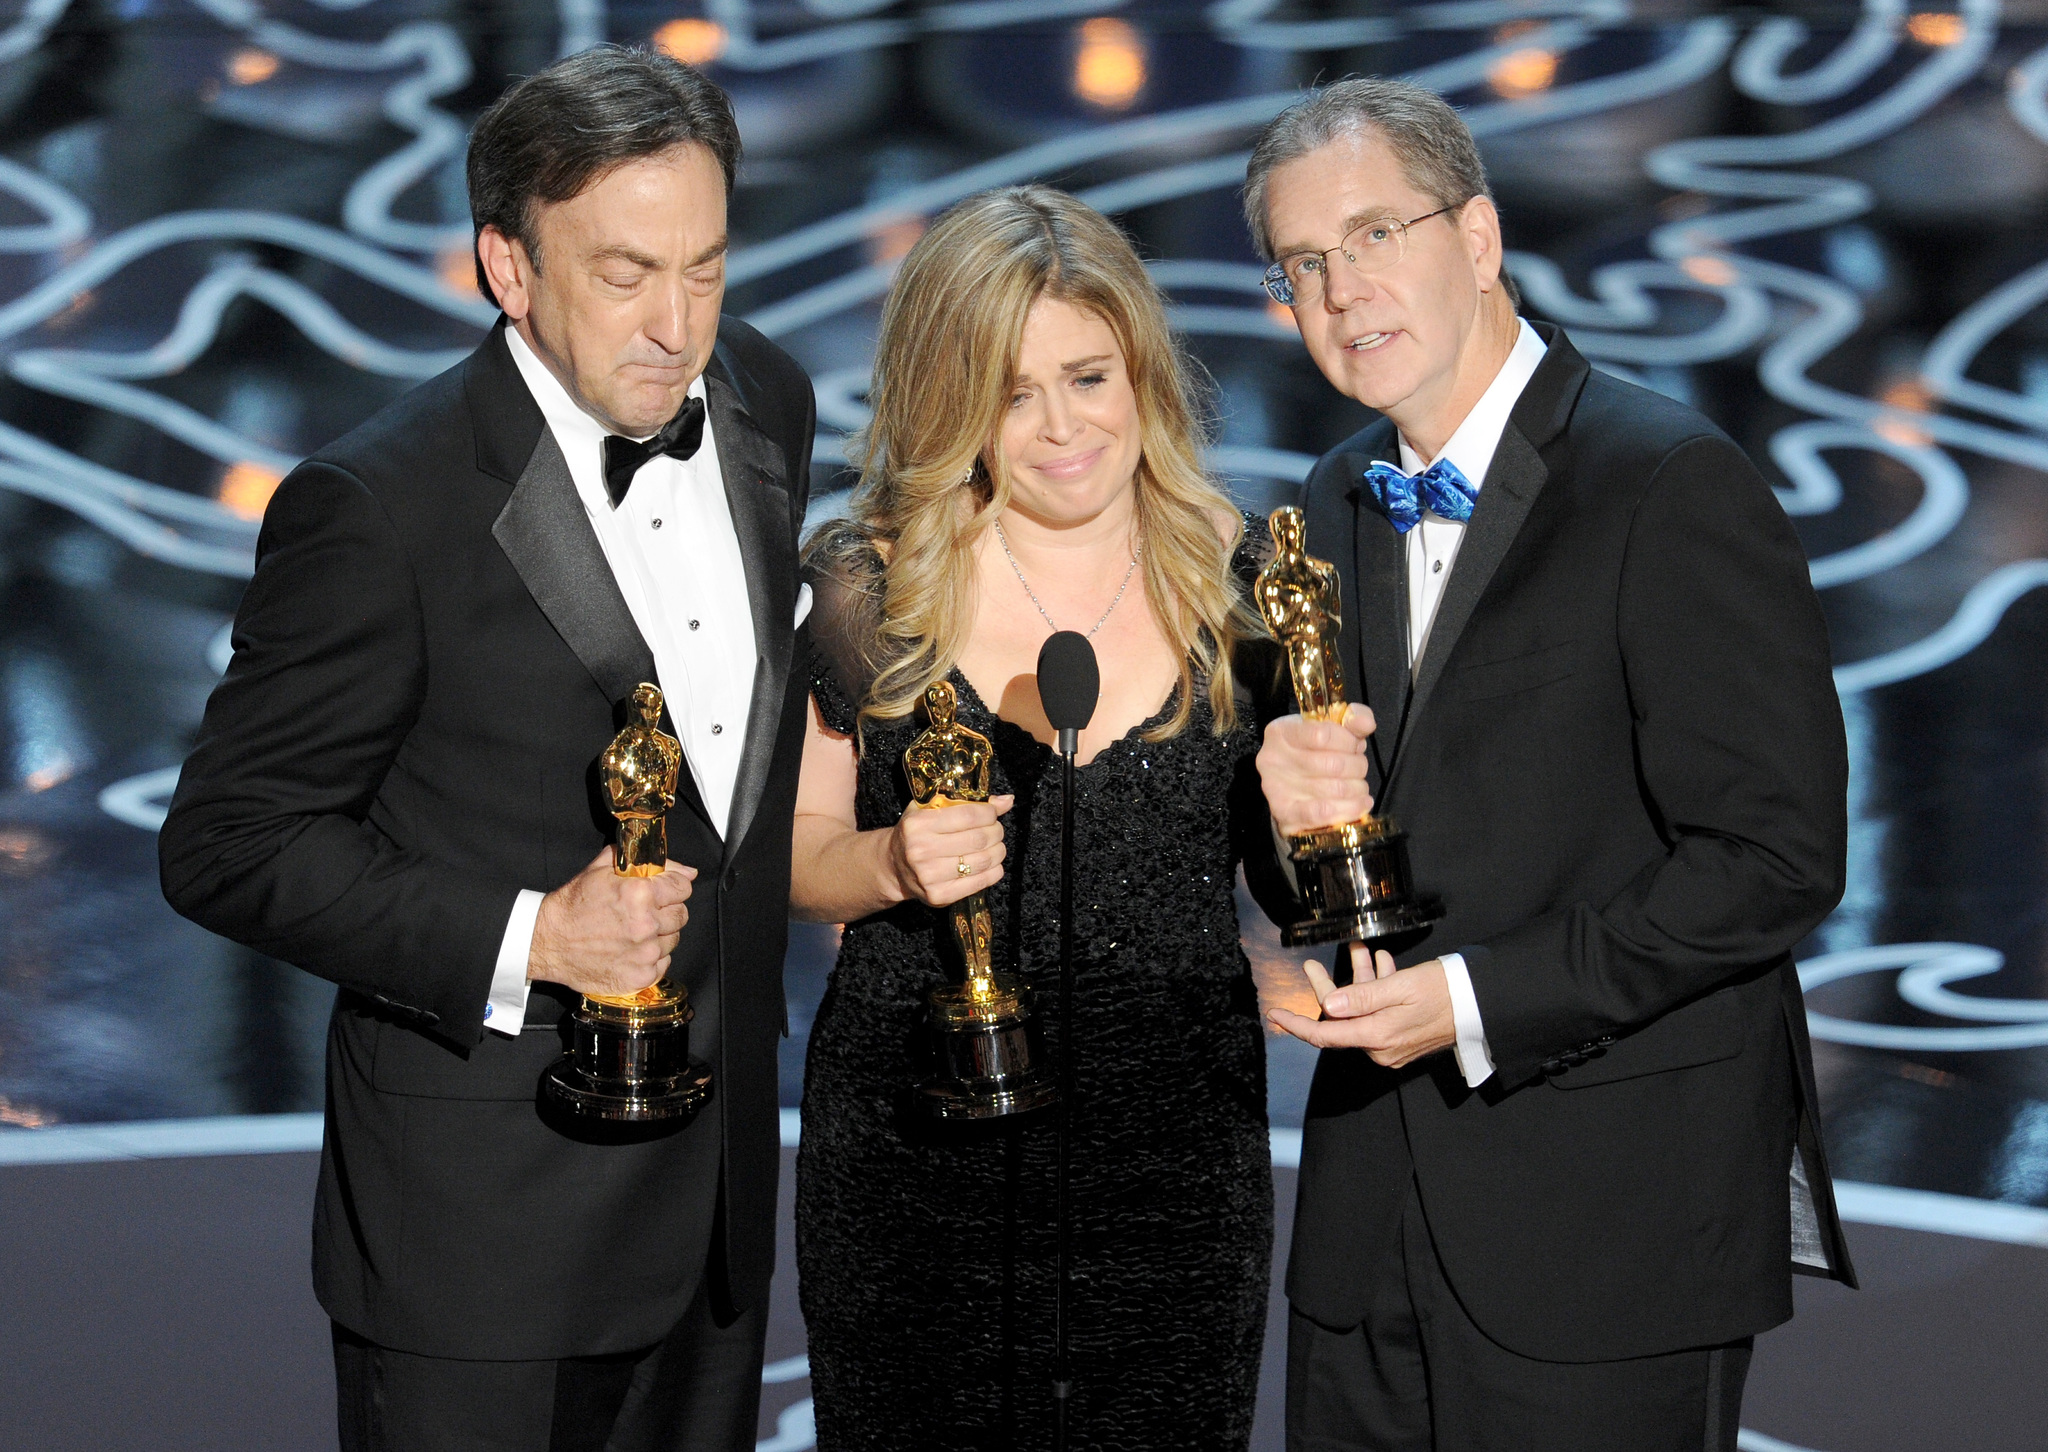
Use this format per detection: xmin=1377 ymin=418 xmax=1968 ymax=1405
xmin=541 ymin=684 xmax=711 ymax=1124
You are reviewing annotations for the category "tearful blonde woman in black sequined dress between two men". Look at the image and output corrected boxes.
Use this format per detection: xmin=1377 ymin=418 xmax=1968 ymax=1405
xmin=791 ymin=186 xmax=1276 ymax=1452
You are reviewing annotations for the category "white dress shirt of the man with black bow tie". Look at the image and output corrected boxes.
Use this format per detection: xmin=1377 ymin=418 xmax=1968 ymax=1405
xmin=483 ymin=328 xmax=756 ymax=1034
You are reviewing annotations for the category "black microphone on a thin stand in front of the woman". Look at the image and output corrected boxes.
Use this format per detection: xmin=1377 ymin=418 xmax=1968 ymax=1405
xmin=1038 ymin=631 xmax=1102 ymax=1452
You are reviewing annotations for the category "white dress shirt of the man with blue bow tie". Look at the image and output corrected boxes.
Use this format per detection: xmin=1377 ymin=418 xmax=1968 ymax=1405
xmin=1401 ymin=322 xmax=1544 ymax=1090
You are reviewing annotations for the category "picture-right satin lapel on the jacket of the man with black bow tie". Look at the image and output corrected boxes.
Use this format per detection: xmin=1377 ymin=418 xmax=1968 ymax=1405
xmin=705 ymin=371 xmax=797 ymax=852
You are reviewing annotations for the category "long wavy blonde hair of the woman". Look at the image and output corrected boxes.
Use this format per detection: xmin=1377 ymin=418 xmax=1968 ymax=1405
xmin=807 ymin=186 xmax=1262 ymax=739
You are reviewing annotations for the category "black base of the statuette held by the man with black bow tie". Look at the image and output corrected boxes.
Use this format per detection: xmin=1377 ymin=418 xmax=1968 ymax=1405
xmin=541 ymin=979 xmax=711 ymax=1124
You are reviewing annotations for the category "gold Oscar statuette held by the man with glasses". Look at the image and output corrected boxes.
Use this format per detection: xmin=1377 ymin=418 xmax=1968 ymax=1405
xmin=1255 ymin=506 xmax=1444 ymax=948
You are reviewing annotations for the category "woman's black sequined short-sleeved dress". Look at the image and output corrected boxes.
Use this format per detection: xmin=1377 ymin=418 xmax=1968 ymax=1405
xmin=797 ymin=522 xmax=1274 ymax=1452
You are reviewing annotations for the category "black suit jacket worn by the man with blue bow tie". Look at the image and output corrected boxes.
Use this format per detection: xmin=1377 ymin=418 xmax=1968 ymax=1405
xmin=1288 ymin=328 xmax=1853 ymax=1362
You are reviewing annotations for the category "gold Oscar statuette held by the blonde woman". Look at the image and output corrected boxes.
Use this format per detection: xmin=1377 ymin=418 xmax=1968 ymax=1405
xmin=903 ymin=680 xmax=1057 ymax=1120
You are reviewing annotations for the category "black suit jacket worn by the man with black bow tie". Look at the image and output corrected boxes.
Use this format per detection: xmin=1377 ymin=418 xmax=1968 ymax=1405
xmin=160 ymin=317 xmax=813 ymax=1360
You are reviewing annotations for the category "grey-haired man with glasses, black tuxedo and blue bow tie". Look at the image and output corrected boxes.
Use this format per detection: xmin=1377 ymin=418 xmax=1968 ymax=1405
xmin=1245 ymin=80 xmax=1853 ymax=1452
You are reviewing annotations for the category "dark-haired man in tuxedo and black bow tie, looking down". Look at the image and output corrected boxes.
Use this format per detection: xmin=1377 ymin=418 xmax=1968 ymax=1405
xmin=162 ymin=47 xmax=813 ymax=1452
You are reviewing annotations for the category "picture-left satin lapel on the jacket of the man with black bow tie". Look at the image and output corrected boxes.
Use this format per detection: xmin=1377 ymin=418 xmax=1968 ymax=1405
xmin=492 ymin=428 xmax=711 ymax=821
